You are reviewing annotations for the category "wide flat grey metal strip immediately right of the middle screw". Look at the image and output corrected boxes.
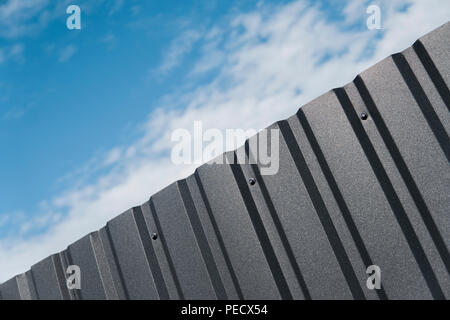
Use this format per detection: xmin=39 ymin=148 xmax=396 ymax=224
xmin=255 ymin=122 xmax=352 ymax=299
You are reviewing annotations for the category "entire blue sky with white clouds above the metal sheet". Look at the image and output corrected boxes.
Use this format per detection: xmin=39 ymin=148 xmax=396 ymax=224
xmin=0 ymin=0 xmax=450 ymax=281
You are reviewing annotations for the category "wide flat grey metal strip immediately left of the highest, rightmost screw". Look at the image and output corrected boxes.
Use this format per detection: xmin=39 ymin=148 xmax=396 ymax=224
xmin=302 ymin=86 xmax=438 ymax=299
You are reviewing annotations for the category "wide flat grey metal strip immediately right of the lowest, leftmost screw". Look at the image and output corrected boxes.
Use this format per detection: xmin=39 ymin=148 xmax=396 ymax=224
xmin=150 ymin=180 xmax=221 ymax=299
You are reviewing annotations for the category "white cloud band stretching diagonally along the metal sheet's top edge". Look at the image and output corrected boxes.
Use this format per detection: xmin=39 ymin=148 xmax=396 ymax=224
xmin=0 ymin=0 xmax=450 ymax=280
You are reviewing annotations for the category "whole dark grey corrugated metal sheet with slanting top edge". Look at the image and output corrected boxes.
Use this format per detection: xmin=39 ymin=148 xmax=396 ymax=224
xmin=0 ymin=23 xmax=450 ymax=299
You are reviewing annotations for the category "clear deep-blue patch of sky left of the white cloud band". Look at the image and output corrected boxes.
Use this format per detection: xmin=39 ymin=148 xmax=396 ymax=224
xmin=0 ymin=1 xmax=256 ymax=218
